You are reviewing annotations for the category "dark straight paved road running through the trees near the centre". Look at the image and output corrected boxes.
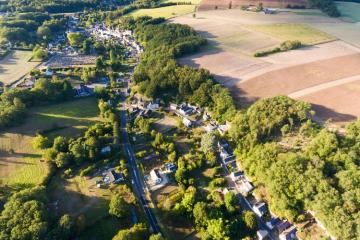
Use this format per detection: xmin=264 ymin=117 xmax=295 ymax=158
xmin=120 ymin=89 xmax=160 ymax=233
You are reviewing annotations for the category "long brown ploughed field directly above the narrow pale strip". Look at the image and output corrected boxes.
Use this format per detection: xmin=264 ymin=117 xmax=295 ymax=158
xmin=234 ymin=54 xmax=360 ymax=102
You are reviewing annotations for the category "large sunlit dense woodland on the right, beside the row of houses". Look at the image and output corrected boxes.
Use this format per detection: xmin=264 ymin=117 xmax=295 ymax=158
xmin=230 ymin=96 xmax=360 ymax=239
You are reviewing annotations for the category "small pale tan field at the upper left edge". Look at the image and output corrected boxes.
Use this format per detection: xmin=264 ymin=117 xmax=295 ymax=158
xmin=0 ymin=50 xmax=39 ymax=85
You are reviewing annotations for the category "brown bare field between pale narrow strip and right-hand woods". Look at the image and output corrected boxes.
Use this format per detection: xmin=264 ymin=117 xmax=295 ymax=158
xmin=300 ymin=79 xmax=360 ymax=124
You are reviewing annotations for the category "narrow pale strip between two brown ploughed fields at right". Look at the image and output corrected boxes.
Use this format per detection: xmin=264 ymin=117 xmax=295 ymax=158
xmin=288 ymin=75 xmax=360 ymax=98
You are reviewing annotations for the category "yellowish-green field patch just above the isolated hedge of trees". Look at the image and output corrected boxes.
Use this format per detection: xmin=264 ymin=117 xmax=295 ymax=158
xmin=248 ymin=23 xmax=335 ymax=45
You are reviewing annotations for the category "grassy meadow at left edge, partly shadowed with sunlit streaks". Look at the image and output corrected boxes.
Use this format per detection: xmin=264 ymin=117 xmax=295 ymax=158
xmin=0 ymin=98 xmax=99 ymax=188
